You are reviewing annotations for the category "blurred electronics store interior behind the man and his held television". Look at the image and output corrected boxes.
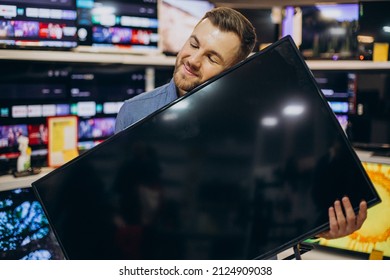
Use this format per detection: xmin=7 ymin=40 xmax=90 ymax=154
xmin=0 ymin=0 xmax=390 ymax=260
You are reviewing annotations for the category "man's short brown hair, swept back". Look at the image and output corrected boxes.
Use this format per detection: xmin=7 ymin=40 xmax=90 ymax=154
xmin=200 ymin=7 xmax=256 ymax=62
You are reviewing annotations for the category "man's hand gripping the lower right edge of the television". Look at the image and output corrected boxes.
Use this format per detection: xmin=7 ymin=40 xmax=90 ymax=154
xmin=318 ymin=197 xmax=367 ymax=239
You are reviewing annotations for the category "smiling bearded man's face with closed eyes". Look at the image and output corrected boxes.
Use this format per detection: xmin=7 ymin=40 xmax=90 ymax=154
xmin=173 ymin=19 xmax=240 ymax=96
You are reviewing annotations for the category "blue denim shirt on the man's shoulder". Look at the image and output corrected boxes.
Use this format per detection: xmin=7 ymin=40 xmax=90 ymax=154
xmin=115 ymin=79 xmax=178 ymax=133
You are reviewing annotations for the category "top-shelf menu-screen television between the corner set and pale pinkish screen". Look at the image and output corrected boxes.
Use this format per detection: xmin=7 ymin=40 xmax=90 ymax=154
xmin=77 ymin=0 xmax=159 ymax=53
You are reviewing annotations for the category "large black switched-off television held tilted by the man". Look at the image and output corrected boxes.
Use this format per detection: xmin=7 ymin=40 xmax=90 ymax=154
xmin=32 ymin=37 xmax=380 ymax=259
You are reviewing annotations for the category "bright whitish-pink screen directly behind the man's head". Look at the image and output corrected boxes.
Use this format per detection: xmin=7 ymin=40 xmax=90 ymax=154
xmin=158 ymin=0 xmax=215 ymax=55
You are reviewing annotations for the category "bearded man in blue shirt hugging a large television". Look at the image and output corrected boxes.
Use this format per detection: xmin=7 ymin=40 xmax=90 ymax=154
xmin=115 ymin=7 xmax=367 ymax=247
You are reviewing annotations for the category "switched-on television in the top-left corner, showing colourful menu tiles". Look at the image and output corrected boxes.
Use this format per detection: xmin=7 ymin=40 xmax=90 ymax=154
xmin=0 ymin=0 xmax=77 ymax=49
